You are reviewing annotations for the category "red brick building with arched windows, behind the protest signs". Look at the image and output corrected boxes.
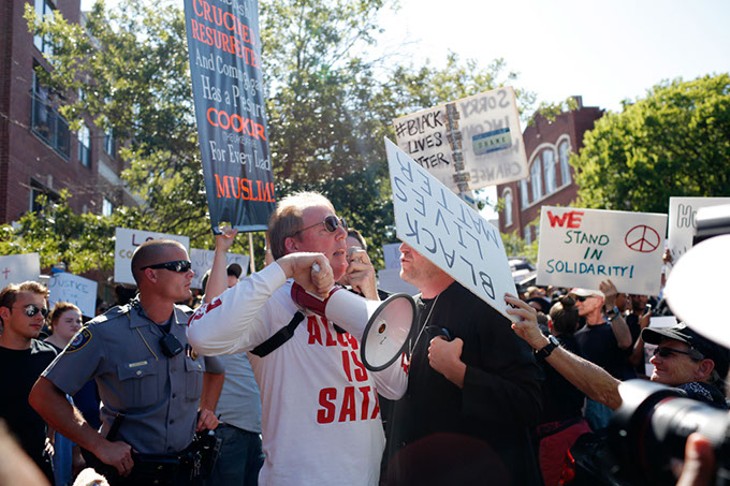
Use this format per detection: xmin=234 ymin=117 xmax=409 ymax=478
xmin=497 ymin=97 xmax=603 ymax=244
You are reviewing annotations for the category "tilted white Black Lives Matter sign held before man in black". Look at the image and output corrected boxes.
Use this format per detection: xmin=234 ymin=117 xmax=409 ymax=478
xmin=385 ymin=139 xmax=516 ymax=319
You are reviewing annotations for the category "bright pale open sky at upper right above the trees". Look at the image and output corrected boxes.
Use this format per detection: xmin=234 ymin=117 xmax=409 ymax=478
xmin=372 ymin=0 xmax=730 ymax=111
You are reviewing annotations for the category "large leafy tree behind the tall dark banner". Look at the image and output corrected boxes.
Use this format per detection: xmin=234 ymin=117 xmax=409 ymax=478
xmin=15 ymin=0 xmax=534 ymax=271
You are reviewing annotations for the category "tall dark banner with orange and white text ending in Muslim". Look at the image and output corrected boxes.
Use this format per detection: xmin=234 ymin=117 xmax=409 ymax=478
xmin=185 ymin=0 xmax=276 ymax=234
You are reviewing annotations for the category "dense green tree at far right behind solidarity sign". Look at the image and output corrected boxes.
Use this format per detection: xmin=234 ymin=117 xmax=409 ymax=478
xmin=571 ymin=73 xmax=730 ymax=213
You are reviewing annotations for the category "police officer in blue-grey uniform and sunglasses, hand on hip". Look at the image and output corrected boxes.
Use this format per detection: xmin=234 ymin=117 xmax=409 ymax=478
xmin=30 ymin=240 xmax=223 ymax=485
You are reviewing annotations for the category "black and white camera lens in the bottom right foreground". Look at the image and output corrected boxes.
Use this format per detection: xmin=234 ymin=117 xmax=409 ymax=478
xmin=608 ymin=380 xmax=730 ymax=485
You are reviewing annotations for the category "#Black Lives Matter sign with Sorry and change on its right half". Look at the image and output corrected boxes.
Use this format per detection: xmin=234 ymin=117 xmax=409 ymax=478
xmin=393 ymin=87 xmax=528 ymax=193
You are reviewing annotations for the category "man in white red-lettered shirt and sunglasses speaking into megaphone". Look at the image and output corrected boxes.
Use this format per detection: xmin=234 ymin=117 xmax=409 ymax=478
xmin=188 ymin=193 xmax=407 ymax=485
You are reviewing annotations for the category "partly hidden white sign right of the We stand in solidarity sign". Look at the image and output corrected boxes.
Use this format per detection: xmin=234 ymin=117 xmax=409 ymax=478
xmin=667 ymin=197 xmax=730 ymax=263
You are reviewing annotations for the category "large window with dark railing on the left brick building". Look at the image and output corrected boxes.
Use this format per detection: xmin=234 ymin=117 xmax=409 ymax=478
xmin=30 ymin=66 xmax=71 ymax=158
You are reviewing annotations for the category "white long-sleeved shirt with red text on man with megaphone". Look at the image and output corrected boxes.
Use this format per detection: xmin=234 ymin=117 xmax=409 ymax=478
xmin=188 ymin=263 xmax=407 ymax=485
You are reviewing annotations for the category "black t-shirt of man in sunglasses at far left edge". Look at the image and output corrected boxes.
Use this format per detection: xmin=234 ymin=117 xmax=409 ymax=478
xmin=0 ymin=339 xmax=56 ymax=464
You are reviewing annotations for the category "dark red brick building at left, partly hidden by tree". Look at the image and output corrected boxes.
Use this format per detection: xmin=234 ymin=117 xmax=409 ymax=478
xmin=0 ymin=0 xmax=134 ymax=223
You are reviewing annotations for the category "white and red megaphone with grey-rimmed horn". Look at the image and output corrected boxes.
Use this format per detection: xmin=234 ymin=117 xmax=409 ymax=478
xmin=291 ymin=283 xmax=416 ymax=371
